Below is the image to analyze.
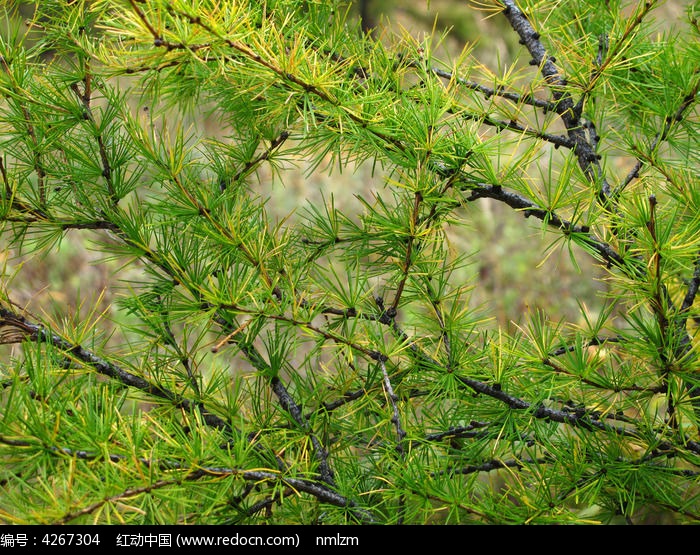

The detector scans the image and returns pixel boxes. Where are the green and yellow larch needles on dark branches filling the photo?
[0,0,700,524]
